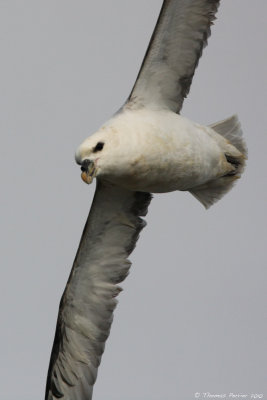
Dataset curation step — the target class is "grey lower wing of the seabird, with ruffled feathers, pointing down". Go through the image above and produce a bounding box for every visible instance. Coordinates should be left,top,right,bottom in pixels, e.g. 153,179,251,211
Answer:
45,181,151,400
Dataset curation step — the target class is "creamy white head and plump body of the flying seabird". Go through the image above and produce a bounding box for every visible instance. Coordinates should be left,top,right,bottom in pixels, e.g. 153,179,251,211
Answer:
76,107,244,203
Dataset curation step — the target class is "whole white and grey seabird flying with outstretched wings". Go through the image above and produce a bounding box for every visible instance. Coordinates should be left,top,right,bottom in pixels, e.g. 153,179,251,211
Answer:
45,0,246,400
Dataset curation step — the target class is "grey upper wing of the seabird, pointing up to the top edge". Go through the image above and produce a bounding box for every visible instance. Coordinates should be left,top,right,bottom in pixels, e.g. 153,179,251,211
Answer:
126,0,220,112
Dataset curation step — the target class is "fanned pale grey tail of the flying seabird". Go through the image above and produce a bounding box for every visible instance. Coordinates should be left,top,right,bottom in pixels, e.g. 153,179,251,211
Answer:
190,115,247,208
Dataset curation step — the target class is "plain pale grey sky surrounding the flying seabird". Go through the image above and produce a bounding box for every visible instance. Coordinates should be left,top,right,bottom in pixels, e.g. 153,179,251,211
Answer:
0,0,267,400
